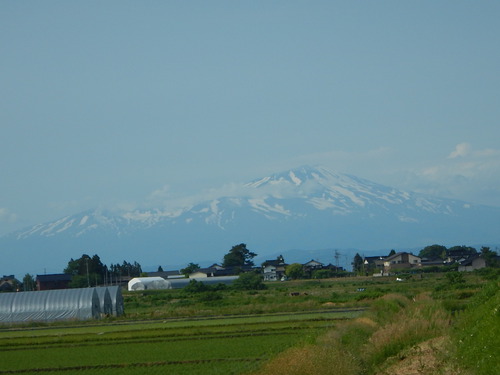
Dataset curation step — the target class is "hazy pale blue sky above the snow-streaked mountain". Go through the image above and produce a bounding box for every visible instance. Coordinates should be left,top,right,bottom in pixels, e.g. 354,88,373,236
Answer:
0,0,500,234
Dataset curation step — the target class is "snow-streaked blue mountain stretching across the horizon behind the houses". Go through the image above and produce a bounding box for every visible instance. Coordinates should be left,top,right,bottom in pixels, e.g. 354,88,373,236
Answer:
0,166,500,275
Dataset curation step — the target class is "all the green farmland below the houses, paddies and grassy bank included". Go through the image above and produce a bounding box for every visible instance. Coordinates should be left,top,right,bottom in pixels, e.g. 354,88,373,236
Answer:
0,274,499,375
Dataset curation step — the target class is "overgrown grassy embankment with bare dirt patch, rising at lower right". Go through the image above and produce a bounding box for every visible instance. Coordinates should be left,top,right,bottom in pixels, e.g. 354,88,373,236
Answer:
248,278,500,375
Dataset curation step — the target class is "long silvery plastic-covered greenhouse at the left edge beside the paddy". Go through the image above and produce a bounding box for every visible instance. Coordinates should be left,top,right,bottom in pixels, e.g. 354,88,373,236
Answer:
0,288,101,323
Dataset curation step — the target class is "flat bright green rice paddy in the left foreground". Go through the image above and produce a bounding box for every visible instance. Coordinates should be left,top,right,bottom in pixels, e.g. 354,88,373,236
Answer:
0,311,359,374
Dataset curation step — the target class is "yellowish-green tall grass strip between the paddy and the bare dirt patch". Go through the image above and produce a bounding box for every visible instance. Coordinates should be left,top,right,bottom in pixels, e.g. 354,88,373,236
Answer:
250,294,450,375
